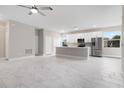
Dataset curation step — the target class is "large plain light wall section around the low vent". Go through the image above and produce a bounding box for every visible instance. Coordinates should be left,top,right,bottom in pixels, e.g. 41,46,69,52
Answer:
8,21,35,58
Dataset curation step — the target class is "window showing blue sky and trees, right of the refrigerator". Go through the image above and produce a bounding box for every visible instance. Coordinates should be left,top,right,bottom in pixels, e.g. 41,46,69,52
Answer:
103,31,121,48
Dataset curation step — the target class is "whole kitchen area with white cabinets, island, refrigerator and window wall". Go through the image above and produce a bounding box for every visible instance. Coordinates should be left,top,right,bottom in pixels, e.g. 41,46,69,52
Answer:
56,26,121,58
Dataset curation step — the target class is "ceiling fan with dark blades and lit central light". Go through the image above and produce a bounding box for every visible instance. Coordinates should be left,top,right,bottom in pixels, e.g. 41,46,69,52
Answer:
18,5,53,16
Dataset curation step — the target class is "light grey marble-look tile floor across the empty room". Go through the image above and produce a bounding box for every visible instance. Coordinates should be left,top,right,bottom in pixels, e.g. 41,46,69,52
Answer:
0,56,124,88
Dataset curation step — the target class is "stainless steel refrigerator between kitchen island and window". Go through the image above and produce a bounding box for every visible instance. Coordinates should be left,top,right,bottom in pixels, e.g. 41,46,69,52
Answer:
91,37,102,57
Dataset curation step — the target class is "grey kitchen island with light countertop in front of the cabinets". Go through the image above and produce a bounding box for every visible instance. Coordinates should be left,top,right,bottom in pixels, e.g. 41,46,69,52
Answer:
56,47,89,59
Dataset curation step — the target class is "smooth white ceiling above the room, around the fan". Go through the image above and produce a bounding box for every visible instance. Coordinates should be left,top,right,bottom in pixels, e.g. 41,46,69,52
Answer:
0,5,122,31
